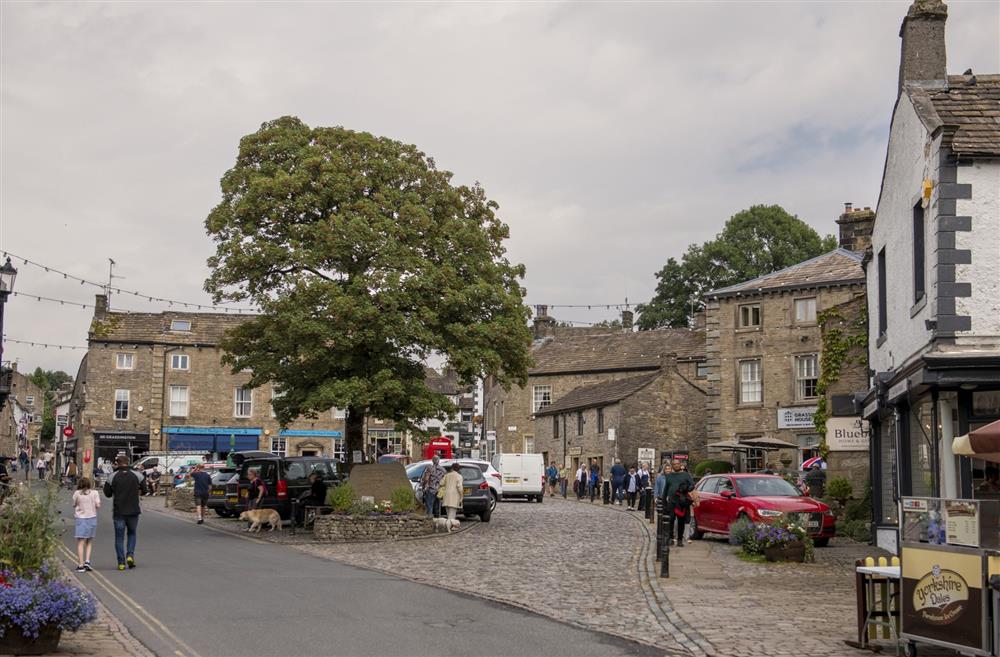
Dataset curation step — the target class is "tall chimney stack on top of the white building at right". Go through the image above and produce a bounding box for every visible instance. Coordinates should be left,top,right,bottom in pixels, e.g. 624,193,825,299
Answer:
897,0,948,96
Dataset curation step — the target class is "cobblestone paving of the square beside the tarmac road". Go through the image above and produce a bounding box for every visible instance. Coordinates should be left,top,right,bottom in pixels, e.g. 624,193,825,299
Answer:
150,497,956,657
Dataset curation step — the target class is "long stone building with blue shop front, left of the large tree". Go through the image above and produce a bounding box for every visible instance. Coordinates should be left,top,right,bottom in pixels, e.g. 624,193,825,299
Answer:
66,295,344,472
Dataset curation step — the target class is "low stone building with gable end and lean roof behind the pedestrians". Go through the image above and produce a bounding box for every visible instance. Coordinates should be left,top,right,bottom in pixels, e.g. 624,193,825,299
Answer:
534,354,706,471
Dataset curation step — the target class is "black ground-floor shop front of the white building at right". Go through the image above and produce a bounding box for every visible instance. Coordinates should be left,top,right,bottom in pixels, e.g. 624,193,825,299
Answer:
863,354,1000,554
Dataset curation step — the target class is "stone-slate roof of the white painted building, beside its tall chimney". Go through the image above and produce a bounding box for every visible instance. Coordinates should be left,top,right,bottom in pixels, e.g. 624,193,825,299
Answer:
906,74,1000,156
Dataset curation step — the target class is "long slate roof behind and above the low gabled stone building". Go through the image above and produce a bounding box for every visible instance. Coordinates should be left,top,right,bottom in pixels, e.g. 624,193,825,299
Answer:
528,329,705,375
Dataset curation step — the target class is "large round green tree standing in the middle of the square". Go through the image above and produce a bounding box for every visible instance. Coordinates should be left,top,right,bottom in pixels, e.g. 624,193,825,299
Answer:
205,117,531,466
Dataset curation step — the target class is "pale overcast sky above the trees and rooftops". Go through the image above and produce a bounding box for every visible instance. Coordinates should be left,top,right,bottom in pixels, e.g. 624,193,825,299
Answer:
0,0,1000,374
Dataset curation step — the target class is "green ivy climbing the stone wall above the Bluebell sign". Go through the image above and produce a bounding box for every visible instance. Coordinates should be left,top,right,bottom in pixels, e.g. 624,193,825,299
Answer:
813,303,868,459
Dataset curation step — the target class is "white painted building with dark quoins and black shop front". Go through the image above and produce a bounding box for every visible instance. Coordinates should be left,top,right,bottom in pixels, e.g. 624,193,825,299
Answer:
864,0,1000,551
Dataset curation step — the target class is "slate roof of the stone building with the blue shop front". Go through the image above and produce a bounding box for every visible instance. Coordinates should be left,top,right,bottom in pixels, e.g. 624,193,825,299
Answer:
88,312,253,346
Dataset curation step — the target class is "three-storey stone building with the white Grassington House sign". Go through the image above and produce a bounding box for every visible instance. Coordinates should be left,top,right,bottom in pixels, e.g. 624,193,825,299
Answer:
706,206,873,481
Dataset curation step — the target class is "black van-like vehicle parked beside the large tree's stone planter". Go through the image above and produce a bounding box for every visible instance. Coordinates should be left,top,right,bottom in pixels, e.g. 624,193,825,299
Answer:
226,454,346,520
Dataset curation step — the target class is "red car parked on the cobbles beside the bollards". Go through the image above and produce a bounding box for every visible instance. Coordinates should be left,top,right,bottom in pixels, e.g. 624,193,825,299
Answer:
691,474,837,547
